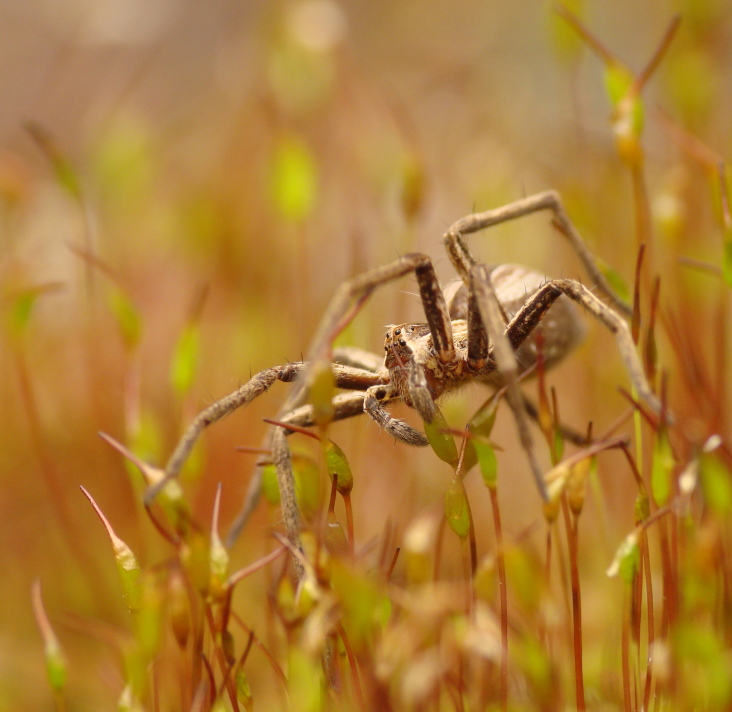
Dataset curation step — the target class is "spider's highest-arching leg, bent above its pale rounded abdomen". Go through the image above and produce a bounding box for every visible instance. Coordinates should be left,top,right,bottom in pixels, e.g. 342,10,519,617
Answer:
443,190,632,316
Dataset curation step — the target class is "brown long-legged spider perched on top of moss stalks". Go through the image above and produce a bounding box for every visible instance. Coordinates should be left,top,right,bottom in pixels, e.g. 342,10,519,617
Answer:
146,191,661,542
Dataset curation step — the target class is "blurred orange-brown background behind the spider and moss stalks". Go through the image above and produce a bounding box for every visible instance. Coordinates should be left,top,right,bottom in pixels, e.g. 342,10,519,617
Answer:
0,0,732,710
